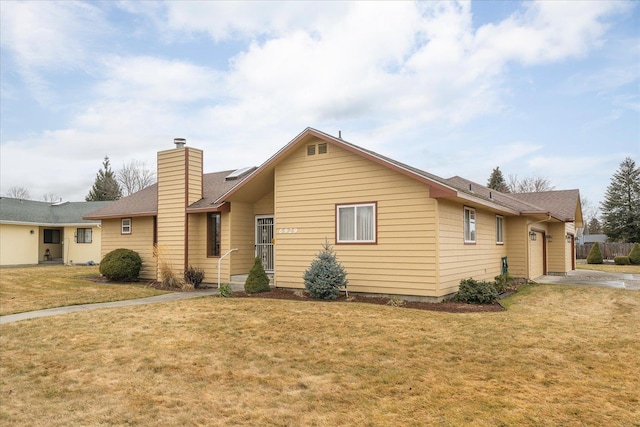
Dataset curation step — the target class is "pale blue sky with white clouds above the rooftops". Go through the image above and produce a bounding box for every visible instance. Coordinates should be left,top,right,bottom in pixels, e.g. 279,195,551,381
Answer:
0,0,640,212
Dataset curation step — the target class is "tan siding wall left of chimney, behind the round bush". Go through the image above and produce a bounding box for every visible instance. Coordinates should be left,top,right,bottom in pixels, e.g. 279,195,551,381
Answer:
100,216,157,280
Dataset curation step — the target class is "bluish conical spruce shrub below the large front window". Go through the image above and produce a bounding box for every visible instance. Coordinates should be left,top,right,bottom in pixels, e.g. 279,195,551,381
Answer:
302,241,349,299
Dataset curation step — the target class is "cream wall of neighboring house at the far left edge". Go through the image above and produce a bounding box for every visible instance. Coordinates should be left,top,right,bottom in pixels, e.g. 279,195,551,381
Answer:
0,224,38,266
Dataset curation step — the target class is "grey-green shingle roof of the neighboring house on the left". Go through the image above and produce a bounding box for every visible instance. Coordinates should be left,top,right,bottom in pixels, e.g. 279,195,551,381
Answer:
0,197,111,226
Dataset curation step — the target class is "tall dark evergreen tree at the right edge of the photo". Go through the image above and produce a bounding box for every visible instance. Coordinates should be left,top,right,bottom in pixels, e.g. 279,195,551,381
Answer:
601,157,640,242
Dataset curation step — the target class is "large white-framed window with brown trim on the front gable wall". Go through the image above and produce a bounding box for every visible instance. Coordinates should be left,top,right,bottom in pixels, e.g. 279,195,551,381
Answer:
336,203,376,243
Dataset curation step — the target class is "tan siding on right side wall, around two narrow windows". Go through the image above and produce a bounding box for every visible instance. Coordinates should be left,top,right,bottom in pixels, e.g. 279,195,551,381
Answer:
438,200,509,295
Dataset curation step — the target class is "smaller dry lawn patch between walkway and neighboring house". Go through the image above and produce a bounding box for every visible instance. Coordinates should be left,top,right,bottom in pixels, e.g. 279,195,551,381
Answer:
0,265,164,315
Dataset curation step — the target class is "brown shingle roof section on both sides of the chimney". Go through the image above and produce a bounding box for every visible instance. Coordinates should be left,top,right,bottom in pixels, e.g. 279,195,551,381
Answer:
85,170,238,219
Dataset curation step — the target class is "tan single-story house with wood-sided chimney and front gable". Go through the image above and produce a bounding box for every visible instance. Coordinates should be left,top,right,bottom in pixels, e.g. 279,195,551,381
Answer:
85,128,582,300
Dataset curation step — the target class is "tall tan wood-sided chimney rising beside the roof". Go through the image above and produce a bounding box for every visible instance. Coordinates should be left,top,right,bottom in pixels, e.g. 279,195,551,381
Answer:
158,147,202,277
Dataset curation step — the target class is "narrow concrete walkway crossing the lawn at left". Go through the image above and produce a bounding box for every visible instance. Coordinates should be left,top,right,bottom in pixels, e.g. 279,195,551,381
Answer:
0,289,219,325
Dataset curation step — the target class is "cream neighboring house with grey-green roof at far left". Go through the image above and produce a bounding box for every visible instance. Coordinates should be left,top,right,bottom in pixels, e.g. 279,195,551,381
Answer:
0,197,110,266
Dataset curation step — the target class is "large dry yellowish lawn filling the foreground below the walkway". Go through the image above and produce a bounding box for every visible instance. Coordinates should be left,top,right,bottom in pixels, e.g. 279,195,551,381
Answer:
0,285,640,426
